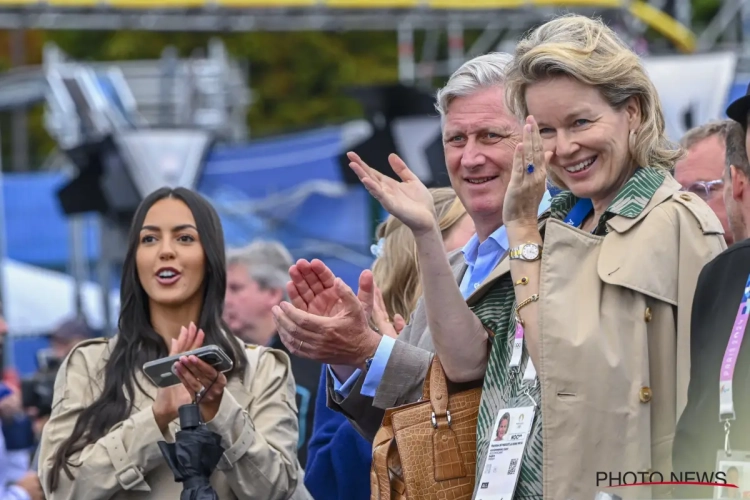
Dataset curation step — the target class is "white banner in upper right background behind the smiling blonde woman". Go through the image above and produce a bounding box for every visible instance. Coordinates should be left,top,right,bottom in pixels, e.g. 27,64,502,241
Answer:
643,52,737,142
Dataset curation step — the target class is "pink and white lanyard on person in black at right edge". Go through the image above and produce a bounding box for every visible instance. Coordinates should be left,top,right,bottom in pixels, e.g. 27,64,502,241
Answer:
719,276,750,453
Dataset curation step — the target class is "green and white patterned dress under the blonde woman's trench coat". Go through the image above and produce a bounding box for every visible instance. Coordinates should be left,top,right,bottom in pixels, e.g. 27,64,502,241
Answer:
472,168,664,500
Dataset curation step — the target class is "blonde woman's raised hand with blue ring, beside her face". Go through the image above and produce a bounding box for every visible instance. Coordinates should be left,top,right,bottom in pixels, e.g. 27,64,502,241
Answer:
503,116,552,227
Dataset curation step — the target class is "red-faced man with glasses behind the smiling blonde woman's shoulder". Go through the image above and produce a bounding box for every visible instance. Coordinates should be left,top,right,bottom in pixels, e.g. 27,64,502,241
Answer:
674,120,734,245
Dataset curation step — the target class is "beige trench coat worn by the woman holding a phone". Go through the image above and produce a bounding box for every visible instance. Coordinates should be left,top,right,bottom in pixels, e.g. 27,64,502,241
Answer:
39,339,309,500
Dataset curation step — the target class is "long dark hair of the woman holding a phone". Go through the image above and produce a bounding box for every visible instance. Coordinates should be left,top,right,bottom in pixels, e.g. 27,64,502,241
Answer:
49,188,247,491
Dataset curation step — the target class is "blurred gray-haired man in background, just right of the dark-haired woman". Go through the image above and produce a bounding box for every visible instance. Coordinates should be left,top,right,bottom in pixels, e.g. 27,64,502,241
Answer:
224,241,321,467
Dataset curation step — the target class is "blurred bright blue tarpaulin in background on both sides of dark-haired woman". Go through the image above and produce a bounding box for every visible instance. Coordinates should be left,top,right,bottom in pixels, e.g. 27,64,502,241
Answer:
3,128,372,286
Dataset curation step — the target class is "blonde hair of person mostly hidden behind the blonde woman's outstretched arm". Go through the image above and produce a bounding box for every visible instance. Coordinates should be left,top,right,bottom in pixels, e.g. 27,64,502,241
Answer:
372,188,466,321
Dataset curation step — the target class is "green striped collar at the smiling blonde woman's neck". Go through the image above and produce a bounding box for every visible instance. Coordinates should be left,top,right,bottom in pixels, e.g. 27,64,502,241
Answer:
550,168,664,220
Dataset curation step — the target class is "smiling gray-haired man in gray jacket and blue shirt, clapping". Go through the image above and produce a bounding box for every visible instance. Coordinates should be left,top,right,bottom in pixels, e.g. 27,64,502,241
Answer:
275,53,549,440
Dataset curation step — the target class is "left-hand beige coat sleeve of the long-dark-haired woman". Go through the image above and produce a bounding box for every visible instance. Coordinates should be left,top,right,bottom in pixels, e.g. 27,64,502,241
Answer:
39,345,164,500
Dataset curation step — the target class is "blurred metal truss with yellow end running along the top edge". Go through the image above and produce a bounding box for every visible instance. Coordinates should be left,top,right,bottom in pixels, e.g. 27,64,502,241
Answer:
0,0,704,52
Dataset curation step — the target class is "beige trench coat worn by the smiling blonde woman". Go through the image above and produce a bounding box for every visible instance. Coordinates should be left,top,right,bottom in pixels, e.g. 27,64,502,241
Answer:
470,176,726,500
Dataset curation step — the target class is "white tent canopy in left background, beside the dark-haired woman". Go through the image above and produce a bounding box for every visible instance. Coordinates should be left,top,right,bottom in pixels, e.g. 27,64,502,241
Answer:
2,259,120,336
